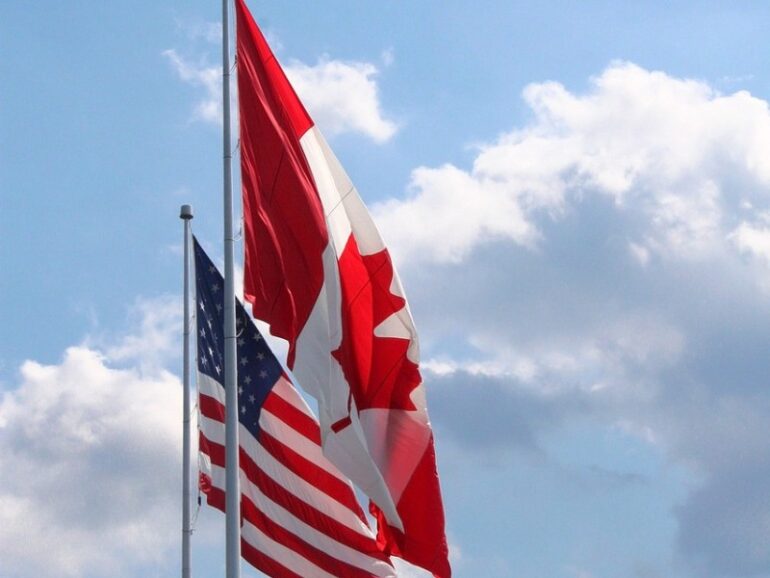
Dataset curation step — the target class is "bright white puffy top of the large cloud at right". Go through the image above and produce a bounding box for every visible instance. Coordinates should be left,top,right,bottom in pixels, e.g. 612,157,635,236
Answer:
374,63,770,262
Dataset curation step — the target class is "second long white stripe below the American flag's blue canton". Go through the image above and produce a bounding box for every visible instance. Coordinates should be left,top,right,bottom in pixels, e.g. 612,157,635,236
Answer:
211,465,395,577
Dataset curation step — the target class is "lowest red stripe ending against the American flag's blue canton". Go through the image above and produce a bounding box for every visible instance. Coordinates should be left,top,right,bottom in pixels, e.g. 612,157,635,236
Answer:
259,430,366,523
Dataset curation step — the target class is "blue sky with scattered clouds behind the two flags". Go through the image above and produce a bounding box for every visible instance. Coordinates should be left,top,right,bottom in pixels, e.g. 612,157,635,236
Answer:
0,0,770,578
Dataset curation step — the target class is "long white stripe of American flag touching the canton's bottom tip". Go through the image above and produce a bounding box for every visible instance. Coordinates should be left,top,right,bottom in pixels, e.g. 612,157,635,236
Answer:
201,417,374,539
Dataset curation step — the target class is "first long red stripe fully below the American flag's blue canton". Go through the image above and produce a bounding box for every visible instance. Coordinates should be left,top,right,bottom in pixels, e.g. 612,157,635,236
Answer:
201,434,387,561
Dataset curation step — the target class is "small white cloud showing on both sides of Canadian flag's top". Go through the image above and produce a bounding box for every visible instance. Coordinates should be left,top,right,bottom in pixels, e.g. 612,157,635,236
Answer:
163,50,398,143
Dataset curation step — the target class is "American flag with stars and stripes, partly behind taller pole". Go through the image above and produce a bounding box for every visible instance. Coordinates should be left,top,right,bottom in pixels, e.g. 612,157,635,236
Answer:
194,239,396,578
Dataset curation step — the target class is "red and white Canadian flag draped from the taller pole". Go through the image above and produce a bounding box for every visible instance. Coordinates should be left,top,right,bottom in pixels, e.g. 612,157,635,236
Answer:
236,0,451,578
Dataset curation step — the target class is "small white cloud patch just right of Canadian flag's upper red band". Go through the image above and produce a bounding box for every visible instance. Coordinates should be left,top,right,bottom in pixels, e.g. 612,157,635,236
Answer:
285,56,398,143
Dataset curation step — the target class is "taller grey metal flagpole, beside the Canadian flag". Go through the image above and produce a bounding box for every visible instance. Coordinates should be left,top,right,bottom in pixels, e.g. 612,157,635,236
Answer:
222,0,241,578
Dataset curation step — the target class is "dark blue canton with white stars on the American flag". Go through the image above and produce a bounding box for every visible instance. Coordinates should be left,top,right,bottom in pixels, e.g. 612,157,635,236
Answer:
193,237,283,438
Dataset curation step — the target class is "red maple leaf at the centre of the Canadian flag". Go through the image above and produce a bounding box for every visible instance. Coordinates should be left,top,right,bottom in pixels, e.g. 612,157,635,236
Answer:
332,235,422,418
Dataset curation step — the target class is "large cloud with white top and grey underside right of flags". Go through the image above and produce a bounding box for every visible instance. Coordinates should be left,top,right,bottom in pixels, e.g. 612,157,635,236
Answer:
382,63,770,578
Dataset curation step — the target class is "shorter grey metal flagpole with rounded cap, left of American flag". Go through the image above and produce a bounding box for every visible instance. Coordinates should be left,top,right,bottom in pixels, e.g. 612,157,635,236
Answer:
179,205,193,578
